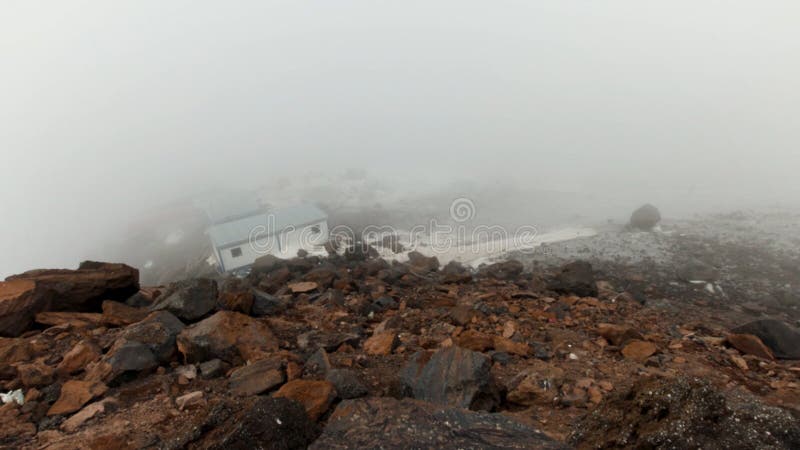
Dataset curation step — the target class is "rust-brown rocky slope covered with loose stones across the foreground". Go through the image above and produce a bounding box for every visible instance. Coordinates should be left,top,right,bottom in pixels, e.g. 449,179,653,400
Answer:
0,214,800,449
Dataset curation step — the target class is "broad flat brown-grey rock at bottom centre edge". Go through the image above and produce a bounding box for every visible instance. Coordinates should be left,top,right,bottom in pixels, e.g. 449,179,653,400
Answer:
309,397,566,450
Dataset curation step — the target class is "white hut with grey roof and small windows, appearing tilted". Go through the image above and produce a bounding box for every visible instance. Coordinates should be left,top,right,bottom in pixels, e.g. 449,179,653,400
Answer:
203,195,328,272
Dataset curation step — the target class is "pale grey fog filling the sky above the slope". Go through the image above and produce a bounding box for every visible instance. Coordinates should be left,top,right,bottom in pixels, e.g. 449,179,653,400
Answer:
0,0,800,277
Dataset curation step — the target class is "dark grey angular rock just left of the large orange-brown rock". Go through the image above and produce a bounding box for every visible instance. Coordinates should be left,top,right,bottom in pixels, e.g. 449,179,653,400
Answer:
119,311,185,363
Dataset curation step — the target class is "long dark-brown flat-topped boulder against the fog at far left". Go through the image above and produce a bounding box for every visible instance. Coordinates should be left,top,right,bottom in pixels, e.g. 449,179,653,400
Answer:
6,261,139,311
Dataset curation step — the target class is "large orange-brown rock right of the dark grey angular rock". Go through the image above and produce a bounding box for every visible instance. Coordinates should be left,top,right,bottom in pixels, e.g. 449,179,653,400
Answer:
177,311,278,365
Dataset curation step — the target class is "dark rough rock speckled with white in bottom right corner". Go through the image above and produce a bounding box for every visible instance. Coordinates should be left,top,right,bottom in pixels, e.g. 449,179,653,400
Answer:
571,378,800,450
